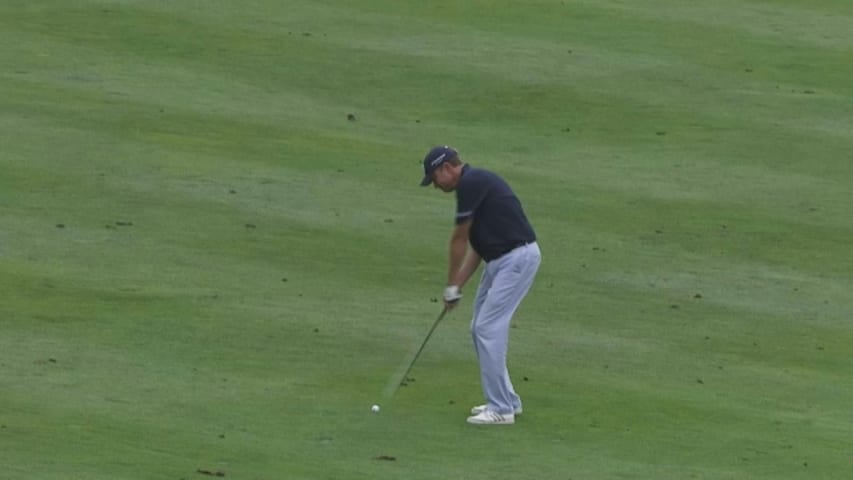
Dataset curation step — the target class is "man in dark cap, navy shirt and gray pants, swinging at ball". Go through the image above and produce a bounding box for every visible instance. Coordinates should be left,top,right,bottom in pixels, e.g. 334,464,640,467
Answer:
421,145,541,425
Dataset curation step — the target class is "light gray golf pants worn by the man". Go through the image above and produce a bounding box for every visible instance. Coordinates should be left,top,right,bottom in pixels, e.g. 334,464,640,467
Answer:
471,243,542,414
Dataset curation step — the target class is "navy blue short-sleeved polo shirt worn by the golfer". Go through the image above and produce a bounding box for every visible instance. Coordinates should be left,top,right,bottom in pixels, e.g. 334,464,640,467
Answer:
456,165,536,262
